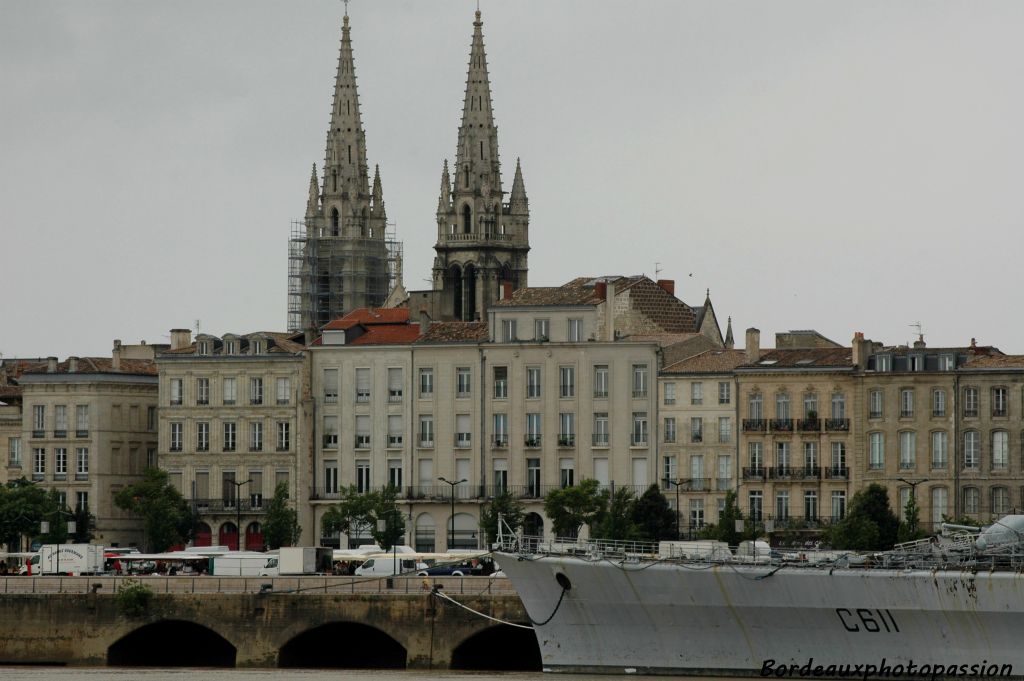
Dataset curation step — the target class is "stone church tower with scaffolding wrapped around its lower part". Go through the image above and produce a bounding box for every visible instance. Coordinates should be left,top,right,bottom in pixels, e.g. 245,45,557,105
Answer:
288,12,390,331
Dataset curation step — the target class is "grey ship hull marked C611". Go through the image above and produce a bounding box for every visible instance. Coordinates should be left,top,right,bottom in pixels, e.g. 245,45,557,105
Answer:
498,555,1024,679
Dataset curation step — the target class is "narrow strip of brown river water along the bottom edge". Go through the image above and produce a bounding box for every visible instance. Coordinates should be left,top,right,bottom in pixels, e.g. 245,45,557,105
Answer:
0,667,728,681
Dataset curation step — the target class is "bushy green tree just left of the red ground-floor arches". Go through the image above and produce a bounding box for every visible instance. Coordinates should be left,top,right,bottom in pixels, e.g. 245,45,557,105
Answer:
114,468,196,553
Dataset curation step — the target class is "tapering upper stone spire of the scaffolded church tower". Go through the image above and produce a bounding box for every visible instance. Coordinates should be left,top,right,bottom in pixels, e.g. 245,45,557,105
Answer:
324,12,370,199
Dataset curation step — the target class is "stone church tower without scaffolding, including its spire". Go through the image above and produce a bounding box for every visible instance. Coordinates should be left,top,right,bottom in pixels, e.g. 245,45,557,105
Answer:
433,10,529,321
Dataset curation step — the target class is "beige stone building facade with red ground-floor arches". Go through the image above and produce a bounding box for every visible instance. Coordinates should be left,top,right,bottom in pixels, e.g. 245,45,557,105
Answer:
157,329,312,550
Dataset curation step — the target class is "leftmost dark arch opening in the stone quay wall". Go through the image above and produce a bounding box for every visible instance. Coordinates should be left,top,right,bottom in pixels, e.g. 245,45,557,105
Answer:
106,620,237,667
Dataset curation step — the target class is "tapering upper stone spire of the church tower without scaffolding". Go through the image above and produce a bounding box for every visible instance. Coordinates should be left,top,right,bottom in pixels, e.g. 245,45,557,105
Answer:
455,10,502,200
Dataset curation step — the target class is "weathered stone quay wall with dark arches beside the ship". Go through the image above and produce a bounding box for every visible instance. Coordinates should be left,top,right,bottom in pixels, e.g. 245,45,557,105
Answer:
0,578,541,671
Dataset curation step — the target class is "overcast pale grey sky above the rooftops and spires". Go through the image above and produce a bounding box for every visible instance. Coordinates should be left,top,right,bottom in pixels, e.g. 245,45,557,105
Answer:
0,0,1024,357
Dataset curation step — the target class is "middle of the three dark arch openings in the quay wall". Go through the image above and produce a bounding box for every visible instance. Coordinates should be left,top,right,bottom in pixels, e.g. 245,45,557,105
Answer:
278,622,408,669
